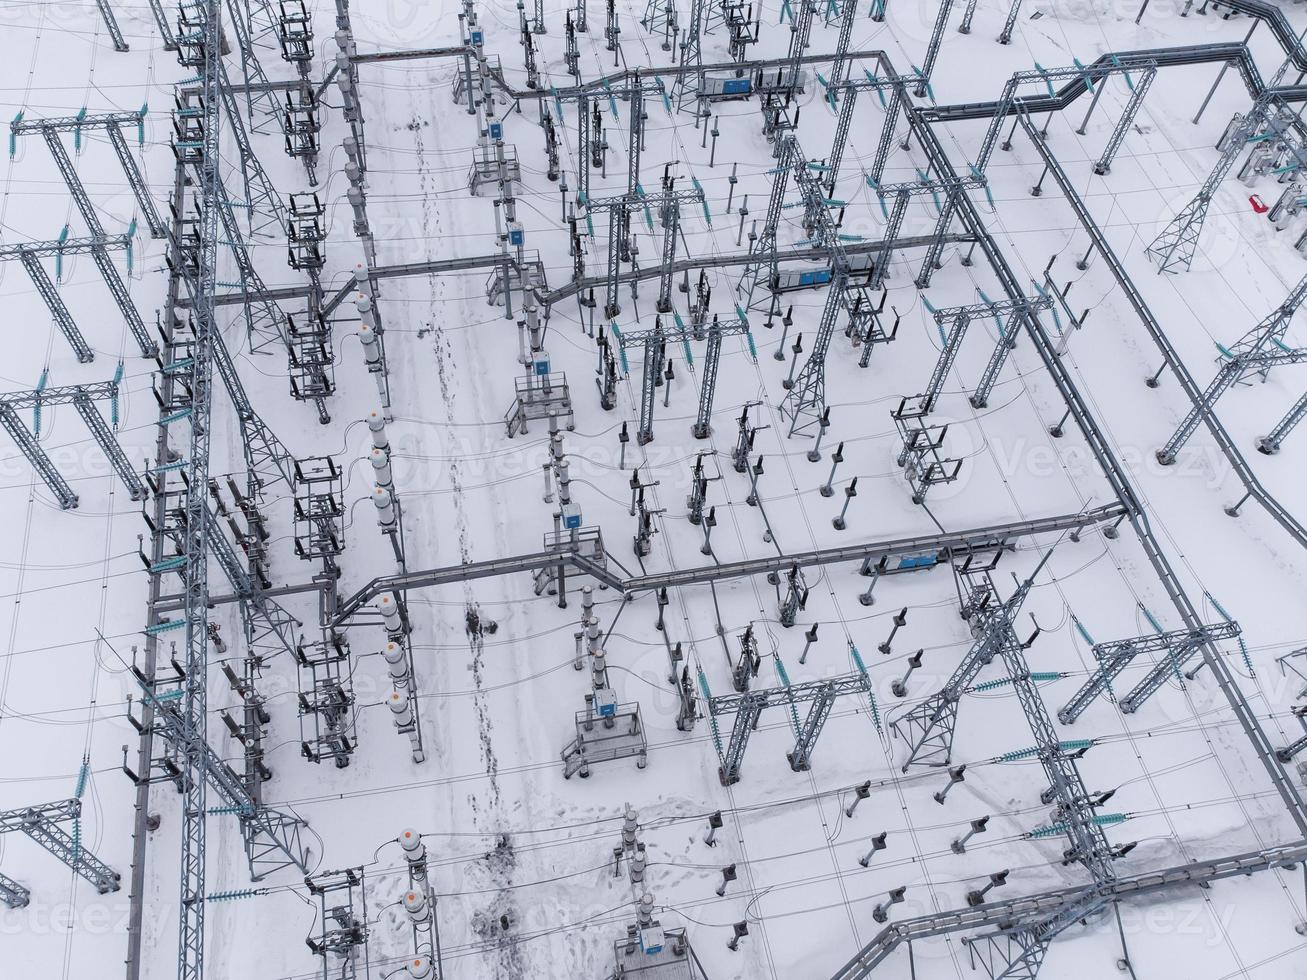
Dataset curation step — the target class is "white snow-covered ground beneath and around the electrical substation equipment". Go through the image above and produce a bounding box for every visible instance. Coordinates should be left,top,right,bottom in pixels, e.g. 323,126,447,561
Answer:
0,0,1307,980
